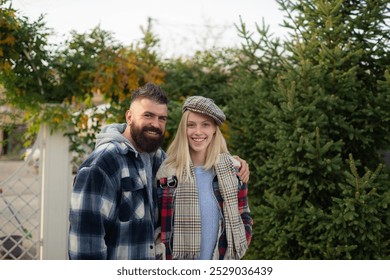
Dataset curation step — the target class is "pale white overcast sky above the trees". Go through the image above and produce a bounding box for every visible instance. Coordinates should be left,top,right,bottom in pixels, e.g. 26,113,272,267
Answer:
12,0,286,56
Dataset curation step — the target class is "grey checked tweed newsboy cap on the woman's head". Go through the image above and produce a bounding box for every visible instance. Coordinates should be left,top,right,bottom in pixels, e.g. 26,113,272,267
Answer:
182,96,226,126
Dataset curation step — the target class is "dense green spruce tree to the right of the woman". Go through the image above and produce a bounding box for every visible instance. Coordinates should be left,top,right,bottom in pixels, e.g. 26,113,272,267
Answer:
232,0,390,259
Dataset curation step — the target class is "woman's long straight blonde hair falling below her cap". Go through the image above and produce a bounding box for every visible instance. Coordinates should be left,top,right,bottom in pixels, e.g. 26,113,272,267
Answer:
165,111,228,181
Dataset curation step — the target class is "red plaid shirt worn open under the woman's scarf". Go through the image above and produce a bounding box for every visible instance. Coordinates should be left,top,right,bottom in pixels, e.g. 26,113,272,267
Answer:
157,176,253,260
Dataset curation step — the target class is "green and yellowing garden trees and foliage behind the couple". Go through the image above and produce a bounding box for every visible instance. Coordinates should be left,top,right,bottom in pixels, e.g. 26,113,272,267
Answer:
0,0,390,259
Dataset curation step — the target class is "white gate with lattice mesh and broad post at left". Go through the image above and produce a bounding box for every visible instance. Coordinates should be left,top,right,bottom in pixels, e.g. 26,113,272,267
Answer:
0,125,73,260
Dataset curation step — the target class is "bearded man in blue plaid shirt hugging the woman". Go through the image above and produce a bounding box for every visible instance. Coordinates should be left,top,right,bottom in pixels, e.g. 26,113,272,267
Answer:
68,83,249,260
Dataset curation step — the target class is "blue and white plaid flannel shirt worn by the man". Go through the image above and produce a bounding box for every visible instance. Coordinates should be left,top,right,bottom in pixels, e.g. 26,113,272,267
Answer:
69,123,165,260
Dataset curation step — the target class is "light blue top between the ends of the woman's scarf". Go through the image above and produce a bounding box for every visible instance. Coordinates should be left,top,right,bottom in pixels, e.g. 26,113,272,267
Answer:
195,167,220,260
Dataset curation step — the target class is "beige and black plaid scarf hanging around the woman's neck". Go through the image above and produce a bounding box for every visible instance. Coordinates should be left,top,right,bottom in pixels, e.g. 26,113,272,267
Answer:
172,154,248,259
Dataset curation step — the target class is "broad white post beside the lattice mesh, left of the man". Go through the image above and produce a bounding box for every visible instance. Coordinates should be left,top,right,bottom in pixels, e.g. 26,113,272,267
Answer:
40,125,72,260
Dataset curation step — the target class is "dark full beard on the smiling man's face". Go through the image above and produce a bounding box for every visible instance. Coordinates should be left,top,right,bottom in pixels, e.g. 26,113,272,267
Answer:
130,122,164,153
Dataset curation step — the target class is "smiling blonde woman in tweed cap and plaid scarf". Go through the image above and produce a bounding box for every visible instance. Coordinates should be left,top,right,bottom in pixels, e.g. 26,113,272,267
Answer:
157,96,253,260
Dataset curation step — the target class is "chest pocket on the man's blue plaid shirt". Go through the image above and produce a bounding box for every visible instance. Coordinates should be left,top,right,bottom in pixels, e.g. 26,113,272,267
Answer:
119,177,147,222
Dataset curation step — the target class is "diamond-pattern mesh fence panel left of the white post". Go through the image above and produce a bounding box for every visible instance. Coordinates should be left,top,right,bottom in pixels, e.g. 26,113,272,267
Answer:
0,135,41,260
